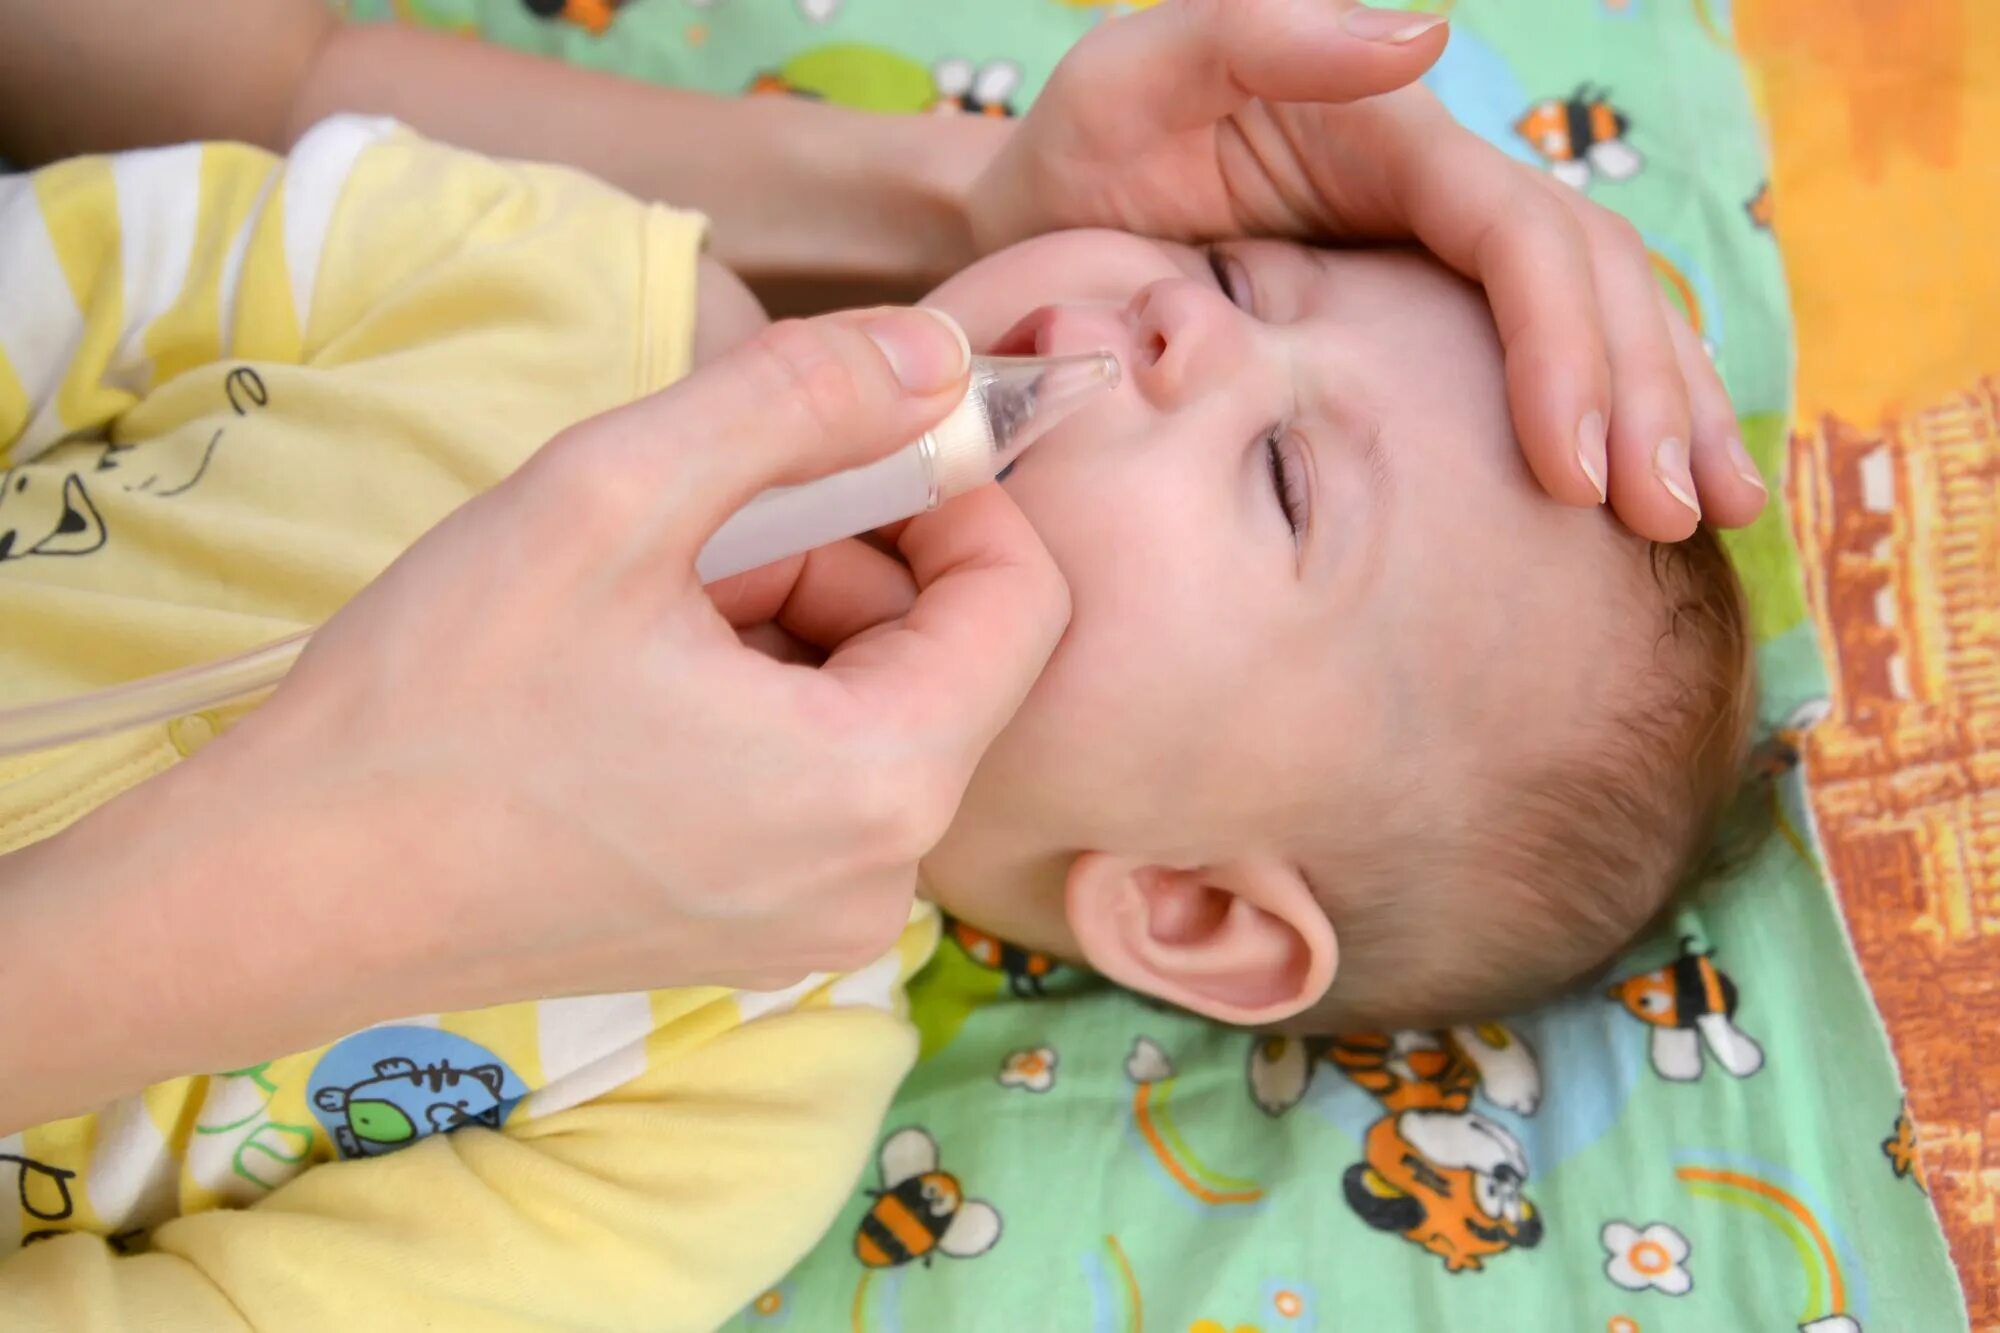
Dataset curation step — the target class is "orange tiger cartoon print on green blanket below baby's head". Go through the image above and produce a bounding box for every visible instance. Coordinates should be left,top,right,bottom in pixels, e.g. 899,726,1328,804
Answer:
1250,1023,1542,1273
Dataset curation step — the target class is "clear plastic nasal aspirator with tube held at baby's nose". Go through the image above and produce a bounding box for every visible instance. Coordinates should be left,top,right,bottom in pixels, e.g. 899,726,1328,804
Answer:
0,352,1118,755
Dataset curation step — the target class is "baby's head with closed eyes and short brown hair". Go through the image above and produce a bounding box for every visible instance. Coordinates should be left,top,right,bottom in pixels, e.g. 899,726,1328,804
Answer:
924,232,1750,1029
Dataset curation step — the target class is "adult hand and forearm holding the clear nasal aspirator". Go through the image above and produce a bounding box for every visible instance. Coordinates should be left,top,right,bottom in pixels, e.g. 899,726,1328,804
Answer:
0,300,1068,1133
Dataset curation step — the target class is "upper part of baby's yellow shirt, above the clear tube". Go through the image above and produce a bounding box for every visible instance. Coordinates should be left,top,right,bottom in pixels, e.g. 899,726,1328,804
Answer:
0,118,704,707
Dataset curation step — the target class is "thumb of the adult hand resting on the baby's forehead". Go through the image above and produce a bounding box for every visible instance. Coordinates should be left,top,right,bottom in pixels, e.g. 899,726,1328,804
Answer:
1056,0,1446,132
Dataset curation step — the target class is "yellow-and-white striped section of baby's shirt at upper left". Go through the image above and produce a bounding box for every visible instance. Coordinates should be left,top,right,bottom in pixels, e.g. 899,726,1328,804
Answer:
0,118,364,464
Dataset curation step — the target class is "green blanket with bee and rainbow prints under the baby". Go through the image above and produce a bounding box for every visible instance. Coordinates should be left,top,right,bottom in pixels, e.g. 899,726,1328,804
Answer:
354,0,1966,1333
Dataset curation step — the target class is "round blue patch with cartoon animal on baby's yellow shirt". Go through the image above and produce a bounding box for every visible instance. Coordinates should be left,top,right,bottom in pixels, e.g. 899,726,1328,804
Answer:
306,1027,526,1157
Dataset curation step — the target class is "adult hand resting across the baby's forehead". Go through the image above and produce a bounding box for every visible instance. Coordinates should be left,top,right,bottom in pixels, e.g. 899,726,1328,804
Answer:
970,0,1764,540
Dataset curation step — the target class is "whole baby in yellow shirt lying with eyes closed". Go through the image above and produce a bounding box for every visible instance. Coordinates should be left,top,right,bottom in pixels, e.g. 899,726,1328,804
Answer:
0,120,1748,1329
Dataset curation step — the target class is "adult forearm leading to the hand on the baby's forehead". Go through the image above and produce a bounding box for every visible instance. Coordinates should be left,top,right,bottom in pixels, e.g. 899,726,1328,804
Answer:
290,24,1006,290
